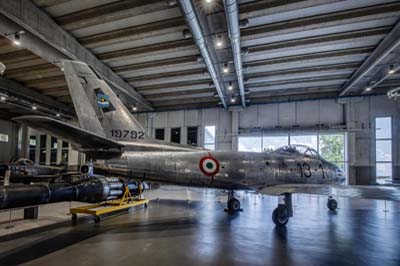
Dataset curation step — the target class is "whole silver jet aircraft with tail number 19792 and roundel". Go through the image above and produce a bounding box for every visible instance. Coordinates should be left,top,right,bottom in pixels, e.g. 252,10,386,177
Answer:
12,60,400,226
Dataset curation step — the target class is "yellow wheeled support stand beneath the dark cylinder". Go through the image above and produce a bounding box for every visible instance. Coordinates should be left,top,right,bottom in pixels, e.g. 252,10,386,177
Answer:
69,184,149,223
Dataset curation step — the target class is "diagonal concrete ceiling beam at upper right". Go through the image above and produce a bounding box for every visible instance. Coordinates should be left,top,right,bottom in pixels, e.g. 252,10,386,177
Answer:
339,17,400,96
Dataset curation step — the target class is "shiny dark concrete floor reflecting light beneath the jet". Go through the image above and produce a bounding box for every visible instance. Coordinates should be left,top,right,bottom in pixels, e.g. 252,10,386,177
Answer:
0,187,400,266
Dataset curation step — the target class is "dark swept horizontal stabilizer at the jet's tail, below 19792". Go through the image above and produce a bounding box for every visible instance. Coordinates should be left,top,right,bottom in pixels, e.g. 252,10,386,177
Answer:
14,115,124,159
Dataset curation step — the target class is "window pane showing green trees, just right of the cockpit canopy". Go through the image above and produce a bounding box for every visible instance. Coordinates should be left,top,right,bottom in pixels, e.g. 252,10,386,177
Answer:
319,134,344,163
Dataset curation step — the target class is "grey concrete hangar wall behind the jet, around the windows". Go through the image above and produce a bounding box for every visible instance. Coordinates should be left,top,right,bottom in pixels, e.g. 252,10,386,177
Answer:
137,95,400,184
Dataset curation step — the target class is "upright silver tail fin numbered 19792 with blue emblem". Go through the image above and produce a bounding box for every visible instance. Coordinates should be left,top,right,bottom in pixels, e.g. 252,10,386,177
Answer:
62,60,149,142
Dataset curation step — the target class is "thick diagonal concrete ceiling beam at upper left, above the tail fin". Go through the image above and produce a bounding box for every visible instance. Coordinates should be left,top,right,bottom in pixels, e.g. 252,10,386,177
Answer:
0,0,153,110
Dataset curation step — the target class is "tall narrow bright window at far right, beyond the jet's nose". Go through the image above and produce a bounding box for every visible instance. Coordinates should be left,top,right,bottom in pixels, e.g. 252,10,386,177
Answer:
375,117,392,183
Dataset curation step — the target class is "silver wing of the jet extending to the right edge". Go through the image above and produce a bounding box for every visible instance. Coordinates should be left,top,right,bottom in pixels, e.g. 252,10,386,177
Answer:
256,184,400,201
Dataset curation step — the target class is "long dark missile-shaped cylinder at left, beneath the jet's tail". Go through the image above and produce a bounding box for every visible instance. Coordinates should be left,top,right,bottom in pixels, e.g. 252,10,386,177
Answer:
0,176,144,209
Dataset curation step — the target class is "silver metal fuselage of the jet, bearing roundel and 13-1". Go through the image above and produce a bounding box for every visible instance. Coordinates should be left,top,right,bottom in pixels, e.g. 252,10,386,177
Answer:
107,151,344,190
